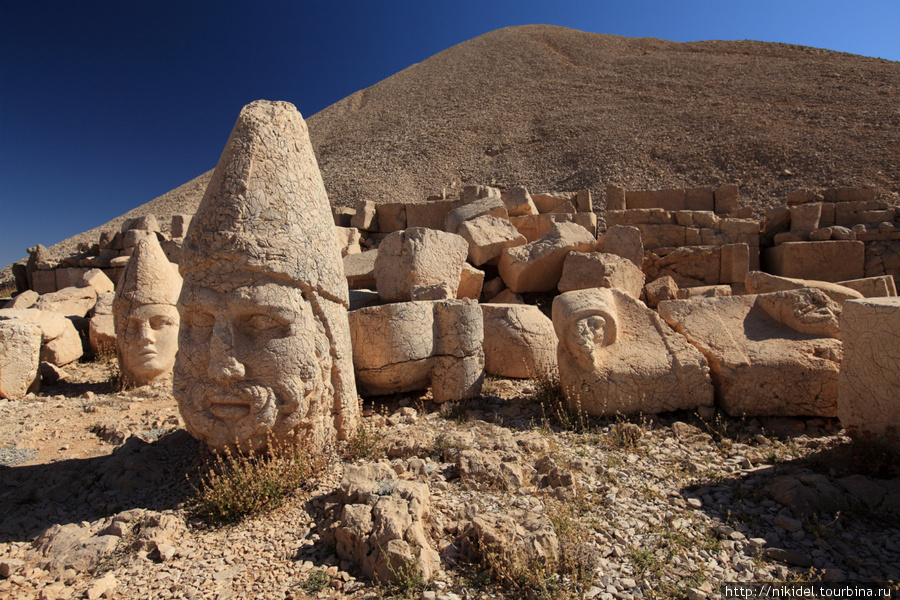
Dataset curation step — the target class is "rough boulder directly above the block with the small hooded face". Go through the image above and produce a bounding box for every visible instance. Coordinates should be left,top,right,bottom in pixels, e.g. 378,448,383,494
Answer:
557,252,644,298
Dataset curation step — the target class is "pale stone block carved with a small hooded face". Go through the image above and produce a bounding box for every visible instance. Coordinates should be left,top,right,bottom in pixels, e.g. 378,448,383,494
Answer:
553,288,713,415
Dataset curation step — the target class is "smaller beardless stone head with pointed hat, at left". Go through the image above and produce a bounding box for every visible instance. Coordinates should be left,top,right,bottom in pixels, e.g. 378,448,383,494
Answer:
113,236,181,385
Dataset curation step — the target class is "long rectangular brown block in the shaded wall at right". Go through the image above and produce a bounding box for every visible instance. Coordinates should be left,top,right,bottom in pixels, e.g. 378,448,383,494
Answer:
763,240,866,282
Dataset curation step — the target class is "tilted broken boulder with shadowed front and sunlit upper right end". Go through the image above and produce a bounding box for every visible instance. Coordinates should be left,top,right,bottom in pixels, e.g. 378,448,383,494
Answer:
499,223,596,293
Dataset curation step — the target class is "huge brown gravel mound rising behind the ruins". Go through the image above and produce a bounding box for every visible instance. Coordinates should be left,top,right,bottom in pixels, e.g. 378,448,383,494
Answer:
26,25,900,264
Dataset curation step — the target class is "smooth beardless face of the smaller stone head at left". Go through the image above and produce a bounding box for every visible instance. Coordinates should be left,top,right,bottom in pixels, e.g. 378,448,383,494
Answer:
118,304,179,385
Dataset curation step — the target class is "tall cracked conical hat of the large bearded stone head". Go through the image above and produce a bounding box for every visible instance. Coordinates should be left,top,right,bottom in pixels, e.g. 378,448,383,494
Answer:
181,100,348,306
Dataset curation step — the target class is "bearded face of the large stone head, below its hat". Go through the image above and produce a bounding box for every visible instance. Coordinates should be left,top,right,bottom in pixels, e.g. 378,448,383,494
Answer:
175,282,331,451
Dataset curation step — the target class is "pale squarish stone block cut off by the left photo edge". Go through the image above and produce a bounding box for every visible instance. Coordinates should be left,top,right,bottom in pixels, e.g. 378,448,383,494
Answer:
0,320,41,400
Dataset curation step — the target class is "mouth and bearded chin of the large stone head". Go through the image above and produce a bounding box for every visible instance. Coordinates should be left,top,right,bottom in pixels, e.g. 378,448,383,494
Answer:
175,381,309,452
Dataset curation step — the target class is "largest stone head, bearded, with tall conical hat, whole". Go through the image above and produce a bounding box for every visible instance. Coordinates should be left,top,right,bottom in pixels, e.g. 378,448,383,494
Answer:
175,101,358,450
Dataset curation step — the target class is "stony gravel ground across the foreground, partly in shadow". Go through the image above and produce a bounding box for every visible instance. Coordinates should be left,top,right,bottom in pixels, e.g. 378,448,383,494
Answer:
0,361,900,600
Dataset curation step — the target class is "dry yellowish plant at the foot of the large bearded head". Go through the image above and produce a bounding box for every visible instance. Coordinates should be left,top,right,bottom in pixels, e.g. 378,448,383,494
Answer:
188,442,327,524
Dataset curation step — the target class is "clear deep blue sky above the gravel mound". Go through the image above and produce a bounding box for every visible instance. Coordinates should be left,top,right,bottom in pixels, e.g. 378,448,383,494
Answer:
0,0,900,267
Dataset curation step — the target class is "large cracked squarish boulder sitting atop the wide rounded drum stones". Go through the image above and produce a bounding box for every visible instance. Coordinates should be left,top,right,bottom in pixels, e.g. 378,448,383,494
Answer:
375,227,469,302
